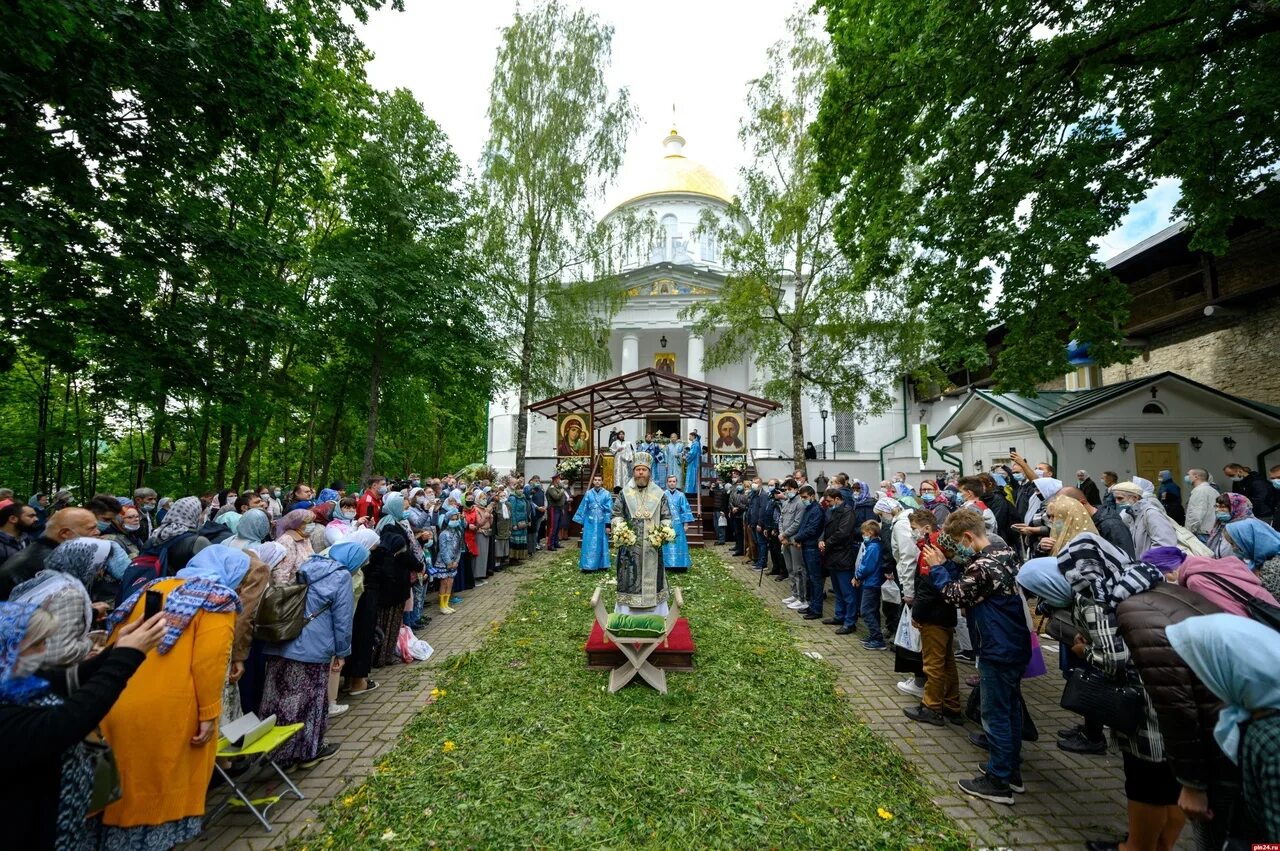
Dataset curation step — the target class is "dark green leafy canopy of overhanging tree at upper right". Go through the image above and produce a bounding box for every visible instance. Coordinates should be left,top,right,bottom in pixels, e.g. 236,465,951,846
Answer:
814,0,1280,392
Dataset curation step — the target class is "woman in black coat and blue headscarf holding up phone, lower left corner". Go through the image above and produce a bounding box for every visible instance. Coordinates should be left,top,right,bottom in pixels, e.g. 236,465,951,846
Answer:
0,601,165,851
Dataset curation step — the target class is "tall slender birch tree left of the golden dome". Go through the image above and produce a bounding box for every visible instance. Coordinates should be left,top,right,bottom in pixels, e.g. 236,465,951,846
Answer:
480,3,634,468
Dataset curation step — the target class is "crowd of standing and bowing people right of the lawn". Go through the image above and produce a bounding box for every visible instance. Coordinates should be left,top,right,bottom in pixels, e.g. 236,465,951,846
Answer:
713,453,1280,851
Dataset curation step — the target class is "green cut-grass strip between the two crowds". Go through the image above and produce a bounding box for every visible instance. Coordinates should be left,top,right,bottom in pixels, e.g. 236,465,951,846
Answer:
297,550,968,850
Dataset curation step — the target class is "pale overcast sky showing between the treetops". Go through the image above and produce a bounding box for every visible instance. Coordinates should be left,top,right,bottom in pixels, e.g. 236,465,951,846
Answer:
361,0,1178,258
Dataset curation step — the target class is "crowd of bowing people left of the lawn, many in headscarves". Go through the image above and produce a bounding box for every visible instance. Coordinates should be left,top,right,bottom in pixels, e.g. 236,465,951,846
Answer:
0,475,560,851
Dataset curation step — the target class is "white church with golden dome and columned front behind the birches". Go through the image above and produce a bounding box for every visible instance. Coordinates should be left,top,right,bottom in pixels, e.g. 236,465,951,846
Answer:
488,128,942,477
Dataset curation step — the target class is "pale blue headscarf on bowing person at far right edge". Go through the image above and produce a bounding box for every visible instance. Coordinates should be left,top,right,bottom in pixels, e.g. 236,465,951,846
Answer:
1165,614,1280,763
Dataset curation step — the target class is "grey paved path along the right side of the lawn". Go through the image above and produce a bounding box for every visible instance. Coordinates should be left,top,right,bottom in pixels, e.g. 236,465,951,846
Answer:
712,548,1194,851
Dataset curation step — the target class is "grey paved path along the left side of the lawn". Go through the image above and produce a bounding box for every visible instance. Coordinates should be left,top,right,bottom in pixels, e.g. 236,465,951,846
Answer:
183,553,552,851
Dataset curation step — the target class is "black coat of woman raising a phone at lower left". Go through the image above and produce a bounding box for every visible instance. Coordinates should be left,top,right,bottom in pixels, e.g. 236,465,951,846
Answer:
0,648,146,848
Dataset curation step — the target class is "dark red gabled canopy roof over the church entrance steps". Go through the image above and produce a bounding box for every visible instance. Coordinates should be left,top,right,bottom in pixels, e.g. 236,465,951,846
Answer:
529,367,782,429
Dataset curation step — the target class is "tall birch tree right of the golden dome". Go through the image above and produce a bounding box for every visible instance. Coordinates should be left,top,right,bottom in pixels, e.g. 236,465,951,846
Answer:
689,13,919,465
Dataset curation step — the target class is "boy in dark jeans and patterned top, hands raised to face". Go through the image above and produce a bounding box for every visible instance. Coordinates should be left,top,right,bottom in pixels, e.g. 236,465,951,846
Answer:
924,511,1032,804
